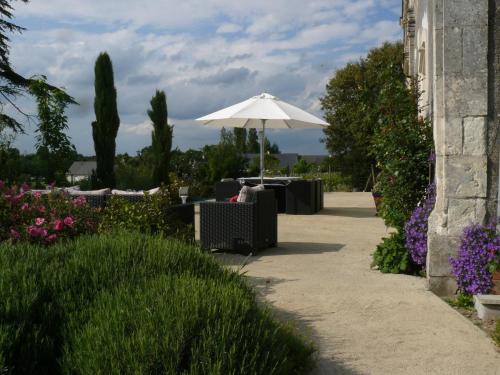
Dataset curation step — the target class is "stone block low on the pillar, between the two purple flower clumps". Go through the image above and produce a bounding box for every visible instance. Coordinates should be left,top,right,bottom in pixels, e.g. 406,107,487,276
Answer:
427,234,460,277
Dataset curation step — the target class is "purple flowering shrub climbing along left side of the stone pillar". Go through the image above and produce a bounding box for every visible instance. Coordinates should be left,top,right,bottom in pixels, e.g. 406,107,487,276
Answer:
405,184,436,267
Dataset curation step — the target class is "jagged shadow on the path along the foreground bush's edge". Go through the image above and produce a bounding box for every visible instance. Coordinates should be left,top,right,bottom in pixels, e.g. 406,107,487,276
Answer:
248,275,365,375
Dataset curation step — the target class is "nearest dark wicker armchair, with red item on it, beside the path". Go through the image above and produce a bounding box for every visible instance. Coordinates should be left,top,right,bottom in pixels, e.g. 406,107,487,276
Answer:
200,190,278,254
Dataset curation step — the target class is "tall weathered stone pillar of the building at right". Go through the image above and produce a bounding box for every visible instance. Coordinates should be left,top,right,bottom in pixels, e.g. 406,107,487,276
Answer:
427,0,498,294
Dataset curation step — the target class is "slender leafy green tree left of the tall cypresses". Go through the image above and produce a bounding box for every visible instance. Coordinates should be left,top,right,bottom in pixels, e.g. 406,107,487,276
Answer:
30,77,76,182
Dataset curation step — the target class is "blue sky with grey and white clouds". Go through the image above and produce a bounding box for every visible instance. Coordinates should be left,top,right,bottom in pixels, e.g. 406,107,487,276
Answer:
11,0,402,155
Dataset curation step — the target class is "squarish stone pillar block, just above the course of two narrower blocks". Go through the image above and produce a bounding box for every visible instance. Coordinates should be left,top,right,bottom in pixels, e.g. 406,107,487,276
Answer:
444,69,488,118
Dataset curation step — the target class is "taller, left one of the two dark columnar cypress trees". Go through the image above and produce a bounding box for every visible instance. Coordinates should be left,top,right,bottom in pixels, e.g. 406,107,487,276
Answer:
92,52,120,188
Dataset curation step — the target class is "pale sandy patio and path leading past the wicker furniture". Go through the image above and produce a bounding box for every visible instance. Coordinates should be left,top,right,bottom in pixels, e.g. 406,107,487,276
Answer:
197,193,500,374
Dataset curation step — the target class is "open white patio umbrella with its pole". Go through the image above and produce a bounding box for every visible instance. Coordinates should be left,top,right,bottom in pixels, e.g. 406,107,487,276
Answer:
196,93,328,183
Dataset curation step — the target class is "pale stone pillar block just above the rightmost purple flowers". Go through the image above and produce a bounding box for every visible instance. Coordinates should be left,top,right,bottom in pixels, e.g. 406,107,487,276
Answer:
448,199,486,235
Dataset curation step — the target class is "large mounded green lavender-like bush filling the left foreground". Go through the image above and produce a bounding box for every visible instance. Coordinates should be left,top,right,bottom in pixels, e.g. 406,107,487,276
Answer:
0,232,313,375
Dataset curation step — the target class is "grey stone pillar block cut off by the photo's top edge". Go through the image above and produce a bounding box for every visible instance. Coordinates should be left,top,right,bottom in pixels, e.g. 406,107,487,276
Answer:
443,0,489,27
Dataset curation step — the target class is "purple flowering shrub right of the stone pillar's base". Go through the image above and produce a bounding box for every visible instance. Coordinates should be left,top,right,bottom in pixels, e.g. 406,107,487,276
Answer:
450,224,500,294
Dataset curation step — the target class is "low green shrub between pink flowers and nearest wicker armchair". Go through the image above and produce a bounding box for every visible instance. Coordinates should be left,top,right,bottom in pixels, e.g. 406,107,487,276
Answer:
99,184,194,240
